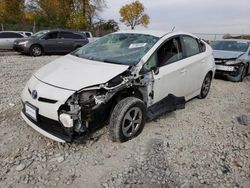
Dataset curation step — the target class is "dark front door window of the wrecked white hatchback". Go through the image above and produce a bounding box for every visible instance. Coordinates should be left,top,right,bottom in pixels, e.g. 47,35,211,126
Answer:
157,37,183,67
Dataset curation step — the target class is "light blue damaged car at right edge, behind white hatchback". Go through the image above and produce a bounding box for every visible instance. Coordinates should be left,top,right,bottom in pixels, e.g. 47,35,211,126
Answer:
212,39,250,82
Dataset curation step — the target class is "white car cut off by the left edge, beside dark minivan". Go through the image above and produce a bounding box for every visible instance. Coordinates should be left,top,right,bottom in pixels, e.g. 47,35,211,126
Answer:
0,31,27,50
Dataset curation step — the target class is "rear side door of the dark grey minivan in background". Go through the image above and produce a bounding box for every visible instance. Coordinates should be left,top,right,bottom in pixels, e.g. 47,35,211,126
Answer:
58,31,75,53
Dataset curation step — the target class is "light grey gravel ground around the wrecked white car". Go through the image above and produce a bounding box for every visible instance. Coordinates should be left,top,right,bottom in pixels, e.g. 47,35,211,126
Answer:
0,52,250,188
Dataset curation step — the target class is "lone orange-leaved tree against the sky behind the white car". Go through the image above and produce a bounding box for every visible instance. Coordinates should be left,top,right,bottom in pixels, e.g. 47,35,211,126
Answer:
120,0,149,29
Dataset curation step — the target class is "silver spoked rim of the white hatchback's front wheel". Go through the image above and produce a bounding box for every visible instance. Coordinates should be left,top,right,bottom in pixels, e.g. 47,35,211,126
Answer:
122,107,142,137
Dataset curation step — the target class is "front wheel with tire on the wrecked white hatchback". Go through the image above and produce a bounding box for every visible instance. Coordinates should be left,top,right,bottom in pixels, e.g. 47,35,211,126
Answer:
109,97,146,142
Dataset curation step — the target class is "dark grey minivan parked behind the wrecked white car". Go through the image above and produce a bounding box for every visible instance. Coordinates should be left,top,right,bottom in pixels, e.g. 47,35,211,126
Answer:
13,30,89,56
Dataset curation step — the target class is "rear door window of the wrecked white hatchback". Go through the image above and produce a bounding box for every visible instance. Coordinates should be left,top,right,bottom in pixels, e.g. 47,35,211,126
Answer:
182,36,200,57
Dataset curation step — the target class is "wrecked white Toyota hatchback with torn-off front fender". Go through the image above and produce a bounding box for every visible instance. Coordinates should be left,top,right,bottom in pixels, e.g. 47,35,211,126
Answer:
21,31,215,142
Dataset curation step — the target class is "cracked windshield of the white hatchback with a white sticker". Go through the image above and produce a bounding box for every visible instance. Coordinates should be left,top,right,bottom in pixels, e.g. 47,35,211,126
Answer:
72,33,159,65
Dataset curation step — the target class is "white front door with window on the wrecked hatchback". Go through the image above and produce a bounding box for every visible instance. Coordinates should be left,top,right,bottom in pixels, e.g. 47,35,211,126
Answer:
151,36,187,103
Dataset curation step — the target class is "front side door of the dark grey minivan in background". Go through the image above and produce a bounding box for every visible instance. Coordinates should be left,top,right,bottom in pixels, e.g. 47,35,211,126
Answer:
40,31,62,53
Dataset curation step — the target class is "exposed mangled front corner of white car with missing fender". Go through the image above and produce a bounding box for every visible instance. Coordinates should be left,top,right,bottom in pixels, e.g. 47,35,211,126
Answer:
58,67,153,139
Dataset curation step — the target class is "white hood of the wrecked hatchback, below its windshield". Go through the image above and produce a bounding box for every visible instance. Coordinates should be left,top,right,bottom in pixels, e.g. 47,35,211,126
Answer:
34,55,129,91
